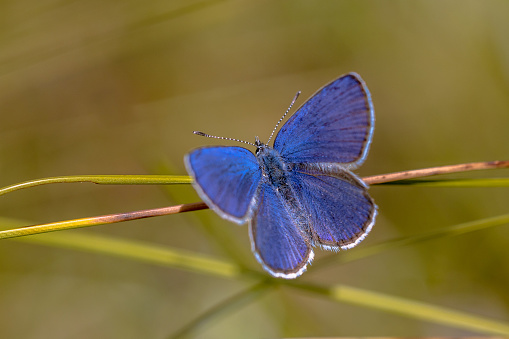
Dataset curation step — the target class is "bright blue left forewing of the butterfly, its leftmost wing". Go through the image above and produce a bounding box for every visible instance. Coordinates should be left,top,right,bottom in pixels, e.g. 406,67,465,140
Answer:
184,146,262,224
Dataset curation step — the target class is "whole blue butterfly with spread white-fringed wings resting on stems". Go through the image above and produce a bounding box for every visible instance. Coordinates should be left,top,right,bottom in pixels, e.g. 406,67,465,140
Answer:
185,73,377,279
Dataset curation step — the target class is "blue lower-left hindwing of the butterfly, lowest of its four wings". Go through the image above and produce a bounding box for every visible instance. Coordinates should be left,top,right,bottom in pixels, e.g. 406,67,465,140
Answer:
249,183,313,279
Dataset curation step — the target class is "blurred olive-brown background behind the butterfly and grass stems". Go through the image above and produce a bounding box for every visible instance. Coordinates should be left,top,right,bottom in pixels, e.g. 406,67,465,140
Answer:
0,0,509,338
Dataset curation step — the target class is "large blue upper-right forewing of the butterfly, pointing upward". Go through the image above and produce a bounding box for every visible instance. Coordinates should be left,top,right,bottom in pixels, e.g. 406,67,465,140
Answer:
274,73,375,169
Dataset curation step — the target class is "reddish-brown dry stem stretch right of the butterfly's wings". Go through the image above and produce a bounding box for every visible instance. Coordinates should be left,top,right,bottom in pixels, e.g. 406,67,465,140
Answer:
362,160,509,185
